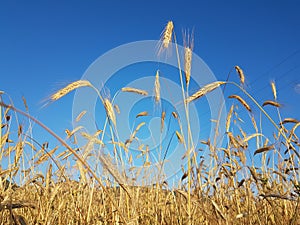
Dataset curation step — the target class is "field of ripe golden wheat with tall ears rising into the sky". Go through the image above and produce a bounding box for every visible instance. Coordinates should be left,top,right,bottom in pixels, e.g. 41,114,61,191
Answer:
0,21,300,225
